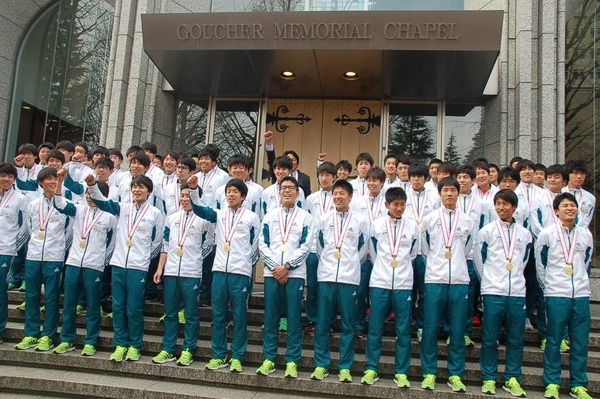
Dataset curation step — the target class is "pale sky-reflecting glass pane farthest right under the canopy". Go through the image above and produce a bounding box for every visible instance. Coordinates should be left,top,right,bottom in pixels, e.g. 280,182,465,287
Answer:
444,105,485,165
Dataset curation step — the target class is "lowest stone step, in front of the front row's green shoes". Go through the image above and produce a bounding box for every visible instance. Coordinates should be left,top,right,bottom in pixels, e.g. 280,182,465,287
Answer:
0,345,580,399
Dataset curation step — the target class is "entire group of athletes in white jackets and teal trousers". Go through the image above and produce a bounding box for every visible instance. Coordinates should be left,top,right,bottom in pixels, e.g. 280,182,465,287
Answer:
0,132,595,399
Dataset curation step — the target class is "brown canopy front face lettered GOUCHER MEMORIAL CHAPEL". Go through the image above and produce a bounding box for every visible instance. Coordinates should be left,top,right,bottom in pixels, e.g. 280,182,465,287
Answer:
142,11,502,51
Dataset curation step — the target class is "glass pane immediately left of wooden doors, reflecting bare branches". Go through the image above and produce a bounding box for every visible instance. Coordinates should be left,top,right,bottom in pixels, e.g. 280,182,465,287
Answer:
213,101,259,169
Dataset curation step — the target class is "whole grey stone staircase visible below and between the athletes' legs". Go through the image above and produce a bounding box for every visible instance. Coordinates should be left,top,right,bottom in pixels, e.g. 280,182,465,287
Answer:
0,292,600,399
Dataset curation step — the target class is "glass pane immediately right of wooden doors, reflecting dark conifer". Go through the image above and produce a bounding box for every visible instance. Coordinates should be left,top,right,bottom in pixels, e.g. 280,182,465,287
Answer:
388,104,437,164
